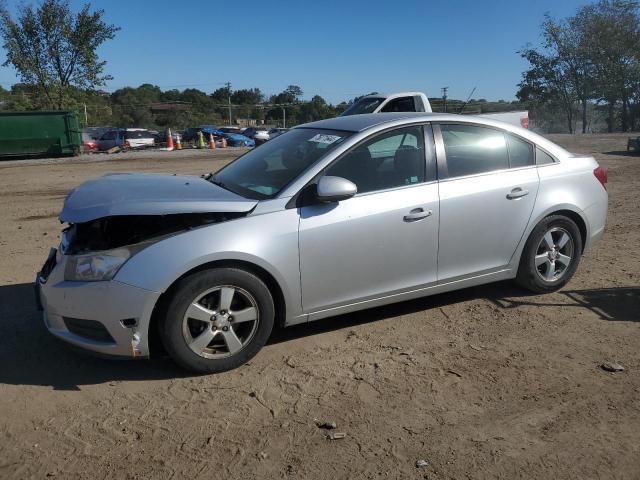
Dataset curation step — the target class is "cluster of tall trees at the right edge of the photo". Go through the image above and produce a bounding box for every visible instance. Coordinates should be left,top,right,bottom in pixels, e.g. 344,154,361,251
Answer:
517,0,640,133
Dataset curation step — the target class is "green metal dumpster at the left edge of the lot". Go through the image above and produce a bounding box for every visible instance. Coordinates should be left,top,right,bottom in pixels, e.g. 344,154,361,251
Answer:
0,112,82,158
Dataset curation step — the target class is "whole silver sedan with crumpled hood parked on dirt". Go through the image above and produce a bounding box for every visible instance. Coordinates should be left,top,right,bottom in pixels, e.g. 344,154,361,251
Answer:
36,113,607,372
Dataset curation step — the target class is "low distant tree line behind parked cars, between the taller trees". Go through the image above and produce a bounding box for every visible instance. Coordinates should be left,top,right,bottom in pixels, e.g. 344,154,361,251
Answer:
0,84,523,129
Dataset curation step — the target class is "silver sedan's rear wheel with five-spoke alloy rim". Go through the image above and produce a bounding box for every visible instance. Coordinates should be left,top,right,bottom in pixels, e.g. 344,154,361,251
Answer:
516,215,582,293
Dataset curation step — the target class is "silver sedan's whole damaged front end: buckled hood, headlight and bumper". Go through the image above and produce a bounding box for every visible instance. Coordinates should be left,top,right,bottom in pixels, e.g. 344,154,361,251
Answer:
35,174,257,358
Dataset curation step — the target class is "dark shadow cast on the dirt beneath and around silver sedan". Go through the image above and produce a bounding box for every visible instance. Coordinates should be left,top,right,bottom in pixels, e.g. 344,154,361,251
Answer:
0,282,640,390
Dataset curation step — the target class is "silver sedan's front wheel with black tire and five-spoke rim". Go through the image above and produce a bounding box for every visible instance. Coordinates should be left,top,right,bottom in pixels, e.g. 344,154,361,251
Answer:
160,268,275,373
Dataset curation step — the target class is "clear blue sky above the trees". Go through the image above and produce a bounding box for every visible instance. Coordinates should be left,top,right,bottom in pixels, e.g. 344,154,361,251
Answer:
0,0,590,103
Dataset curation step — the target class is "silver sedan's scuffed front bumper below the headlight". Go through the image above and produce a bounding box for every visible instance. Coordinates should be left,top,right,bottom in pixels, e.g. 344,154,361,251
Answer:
36,256,160,358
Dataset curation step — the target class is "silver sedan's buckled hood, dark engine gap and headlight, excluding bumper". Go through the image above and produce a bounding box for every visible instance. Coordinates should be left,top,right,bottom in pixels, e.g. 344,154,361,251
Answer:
55,174,256,282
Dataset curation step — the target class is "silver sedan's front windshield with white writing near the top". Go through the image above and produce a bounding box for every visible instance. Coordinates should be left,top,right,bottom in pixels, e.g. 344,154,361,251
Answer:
210,128,351,200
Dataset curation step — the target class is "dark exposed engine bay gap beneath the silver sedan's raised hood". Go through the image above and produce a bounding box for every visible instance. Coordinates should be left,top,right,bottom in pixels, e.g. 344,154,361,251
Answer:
62,212,246,255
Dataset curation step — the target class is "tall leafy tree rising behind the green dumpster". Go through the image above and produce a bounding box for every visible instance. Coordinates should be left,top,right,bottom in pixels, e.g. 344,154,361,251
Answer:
0,0,119,108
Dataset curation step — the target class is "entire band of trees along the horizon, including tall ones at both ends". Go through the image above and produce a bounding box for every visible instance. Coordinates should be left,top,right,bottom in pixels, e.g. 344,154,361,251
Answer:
0,0,640,132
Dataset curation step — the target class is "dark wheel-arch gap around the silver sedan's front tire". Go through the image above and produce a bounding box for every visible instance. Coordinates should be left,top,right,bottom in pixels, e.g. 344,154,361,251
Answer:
148,260,287,355
